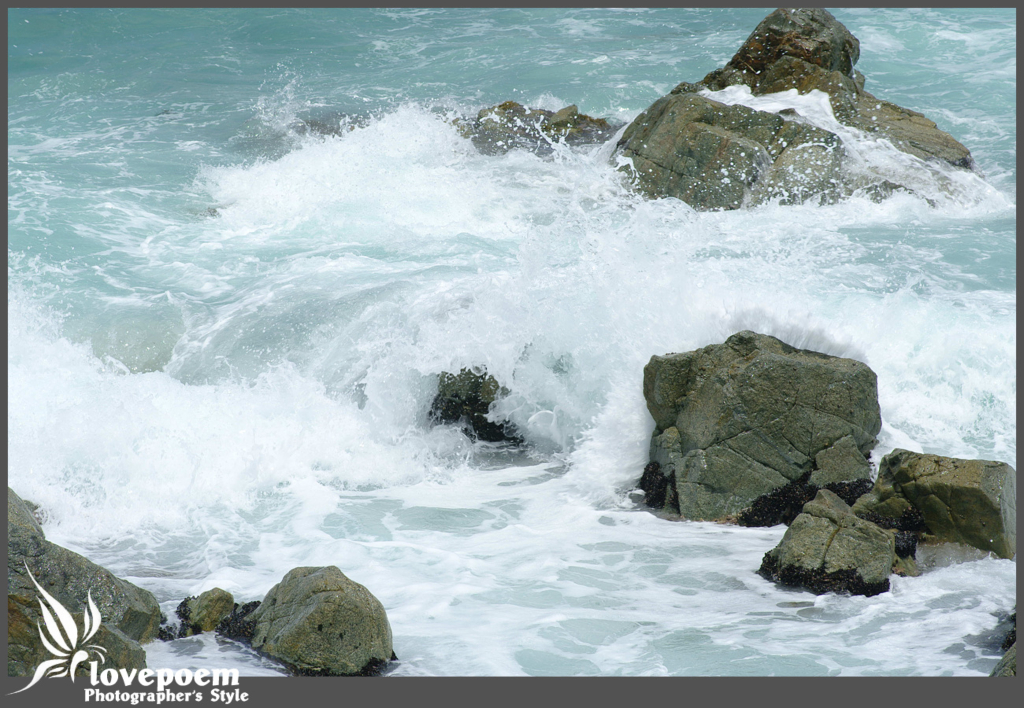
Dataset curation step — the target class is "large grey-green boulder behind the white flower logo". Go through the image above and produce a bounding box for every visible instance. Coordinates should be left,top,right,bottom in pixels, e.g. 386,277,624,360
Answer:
7,487,161,676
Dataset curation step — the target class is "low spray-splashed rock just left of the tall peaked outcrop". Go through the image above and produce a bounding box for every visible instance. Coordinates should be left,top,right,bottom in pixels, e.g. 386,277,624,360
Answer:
457,100,622,155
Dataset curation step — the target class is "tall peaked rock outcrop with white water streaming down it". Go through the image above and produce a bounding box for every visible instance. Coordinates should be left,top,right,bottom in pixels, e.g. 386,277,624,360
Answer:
612,8,974,210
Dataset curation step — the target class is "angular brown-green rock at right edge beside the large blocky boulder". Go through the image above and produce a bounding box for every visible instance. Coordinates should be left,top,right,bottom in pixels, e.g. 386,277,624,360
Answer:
853,449,1017,558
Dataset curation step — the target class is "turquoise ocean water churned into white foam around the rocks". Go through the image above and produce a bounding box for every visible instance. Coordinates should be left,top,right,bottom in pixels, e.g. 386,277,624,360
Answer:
7,9,1017,676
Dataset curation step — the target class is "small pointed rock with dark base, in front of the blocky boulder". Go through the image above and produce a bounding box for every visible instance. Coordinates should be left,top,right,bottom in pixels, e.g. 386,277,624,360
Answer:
758,490,896,596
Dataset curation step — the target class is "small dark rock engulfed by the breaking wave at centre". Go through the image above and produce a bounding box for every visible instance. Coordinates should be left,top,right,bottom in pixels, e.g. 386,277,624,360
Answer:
430,369,522,444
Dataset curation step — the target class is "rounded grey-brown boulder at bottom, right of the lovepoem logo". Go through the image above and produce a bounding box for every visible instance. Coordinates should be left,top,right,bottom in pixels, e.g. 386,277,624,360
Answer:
252,566,394,676
